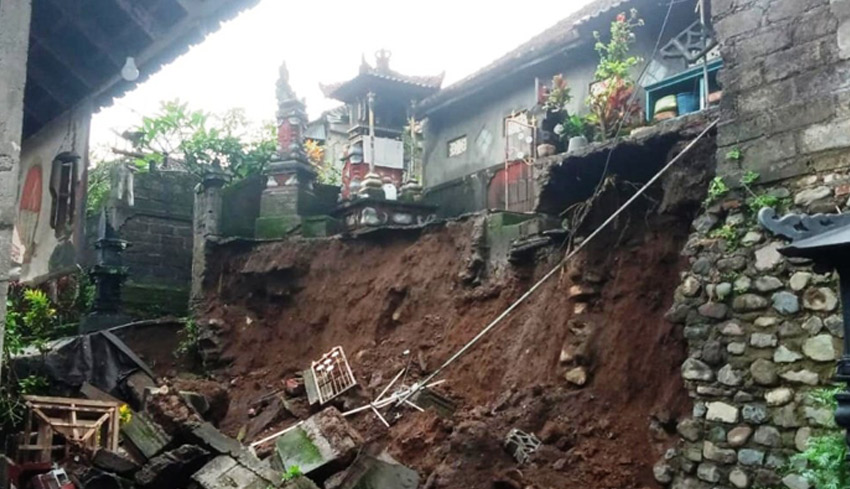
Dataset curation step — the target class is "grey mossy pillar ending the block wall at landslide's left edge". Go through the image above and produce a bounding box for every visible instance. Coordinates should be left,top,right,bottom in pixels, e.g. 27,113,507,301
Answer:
189,171,227,311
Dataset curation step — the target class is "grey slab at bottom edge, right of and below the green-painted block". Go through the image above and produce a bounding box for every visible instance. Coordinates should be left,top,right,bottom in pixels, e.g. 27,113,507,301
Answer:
325,453,419,489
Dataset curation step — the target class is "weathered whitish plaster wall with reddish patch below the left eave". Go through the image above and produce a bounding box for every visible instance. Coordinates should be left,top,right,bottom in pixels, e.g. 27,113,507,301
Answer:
13,104,92,282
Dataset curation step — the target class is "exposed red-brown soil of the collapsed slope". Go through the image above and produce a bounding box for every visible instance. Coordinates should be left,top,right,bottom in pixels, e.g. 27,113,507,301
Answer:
203,188,689,489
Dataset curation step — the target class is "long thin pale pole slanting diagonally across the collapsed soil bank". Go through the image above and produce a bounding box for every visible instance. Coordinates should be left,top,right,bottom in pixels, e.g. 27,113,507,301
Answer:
396,120,718,406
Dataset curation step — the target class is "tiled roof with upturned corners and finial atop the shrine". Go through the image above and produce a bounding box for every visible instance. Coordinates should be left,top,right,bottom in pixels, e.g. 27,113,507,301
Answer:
319,50,445,102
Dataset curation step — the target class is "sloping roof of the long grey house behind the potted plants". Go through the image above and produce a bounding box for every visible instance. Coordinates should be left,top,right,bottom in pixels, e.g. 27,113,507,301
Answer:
419,0,640,114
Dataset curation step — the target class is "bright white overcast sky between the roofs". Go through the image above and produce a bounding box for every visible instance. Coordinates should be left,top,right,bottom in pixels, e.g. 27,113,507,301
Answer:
91,0,590,154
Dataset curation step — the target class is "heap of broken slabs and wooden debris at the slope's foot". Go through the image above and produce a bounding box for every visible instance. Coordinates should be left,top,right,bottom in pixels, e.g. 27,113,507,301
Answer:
3,346,419,489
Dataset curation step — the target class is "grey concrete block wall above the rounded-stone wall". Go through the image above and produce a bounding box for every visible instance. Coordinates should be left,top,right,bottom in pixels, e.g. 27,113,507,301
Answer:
711,0,850,181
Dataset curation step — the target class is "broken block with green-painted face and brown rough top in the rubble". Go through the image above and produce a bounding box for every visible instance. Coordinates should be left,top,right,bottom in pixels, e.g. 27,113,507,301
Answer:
275,407,363,474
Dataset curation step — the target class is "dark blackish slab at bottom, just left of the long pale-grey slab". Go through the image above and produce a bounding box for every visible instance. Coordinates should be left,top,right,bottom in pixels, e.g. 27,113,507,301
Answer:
135,445,210,488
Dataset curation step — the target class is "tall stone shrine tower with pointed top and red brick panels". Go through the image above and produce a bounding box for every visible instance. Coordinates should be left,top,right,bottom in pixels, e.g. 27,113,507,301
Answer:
255,64,316,239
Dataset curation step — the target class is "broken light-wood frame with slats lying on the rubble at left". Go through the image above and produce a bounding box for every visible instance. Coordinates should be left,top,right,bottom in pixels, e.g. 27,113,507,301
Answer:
18,396,121,463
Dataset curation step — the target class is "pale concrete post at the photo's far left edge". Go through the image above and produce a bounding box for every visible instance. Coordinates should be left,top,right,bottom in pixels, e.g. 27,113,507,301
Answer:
0,0,32,374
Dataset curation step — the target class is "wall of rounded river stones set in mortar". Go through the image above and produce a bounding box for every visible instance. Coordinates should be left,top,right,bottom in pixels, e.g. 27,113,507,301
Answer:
655,171,850,489
